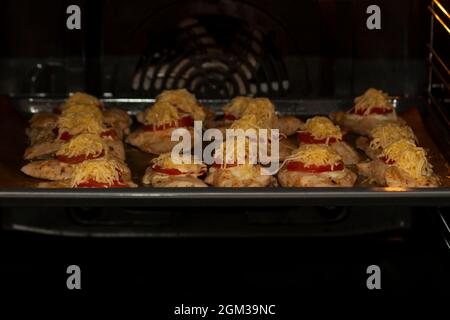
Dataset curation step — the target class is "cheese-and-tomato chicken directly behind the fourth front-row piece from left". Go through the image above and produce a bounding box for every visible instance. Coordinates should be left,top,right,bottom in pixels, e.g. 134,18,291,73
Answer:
298,116,359,165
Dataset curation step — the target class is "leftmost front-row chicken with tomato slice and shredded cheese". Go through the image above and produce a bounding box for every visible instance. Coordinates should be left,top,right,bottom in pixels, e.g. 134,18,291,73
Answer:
38,159,137,188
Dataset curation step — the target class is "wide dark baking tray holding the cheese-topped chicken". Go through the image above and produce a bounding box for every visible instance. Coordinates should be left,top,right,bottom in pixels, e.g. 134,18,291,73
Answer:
0,96,450,207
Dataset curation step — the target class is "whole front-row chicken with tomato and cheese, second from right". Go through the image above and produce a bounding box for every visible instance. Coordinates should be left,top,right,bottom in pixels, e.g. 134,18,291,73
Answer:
278,144,357,187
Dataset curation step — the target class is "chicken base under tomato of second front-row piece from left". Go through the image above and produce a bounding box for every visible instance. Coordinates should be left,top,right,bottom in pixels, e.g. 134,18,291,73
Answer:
142,166,207,188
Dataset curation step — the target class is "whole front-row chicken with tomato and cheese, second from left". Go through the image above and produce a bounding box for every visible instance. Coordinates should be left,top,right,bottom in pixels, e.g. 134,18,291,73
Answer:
142,153,207,187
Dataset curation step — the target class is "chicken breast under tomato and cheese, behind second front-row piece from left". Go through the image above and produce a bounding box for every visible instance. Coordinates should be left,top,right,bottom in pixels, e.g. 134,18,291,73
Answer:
126,128,194,154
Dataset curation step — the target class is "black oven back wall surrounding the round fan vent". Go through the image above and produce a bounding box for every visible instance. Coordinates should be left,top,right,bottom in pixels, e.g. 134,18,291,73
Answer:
0,0,429,97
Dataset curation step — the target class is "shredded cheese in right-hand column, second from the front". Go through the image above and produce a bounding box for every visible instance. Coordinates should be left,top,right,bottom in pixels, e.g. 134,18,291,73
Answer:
370,123,417,150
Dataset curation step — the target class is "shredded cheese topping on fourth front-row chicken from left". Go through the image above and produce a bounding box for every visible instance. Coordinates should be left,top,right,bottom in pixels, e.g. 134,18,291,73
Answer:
283,144,342,168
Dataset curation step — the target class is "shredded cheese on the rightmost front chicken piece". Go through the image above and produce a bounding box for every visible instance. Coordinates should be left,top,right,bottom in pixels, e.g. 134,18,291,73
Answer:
381,139,433,179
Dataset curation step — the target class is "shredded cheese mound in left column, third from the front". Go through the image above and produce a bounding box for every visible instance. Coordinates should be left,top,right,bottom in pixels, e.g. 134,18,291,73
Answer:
58,112,104,135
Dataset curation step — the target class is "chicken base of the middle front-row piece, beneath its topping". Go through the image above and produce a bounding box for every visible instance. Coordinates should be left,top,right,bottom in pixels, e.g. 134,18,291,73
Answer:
205,165,274,188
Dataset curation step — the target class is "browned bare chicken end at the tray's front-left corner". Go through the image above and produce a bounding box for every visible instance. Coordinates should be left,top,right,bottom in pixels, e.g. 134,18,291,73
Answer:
21,159,74,180
